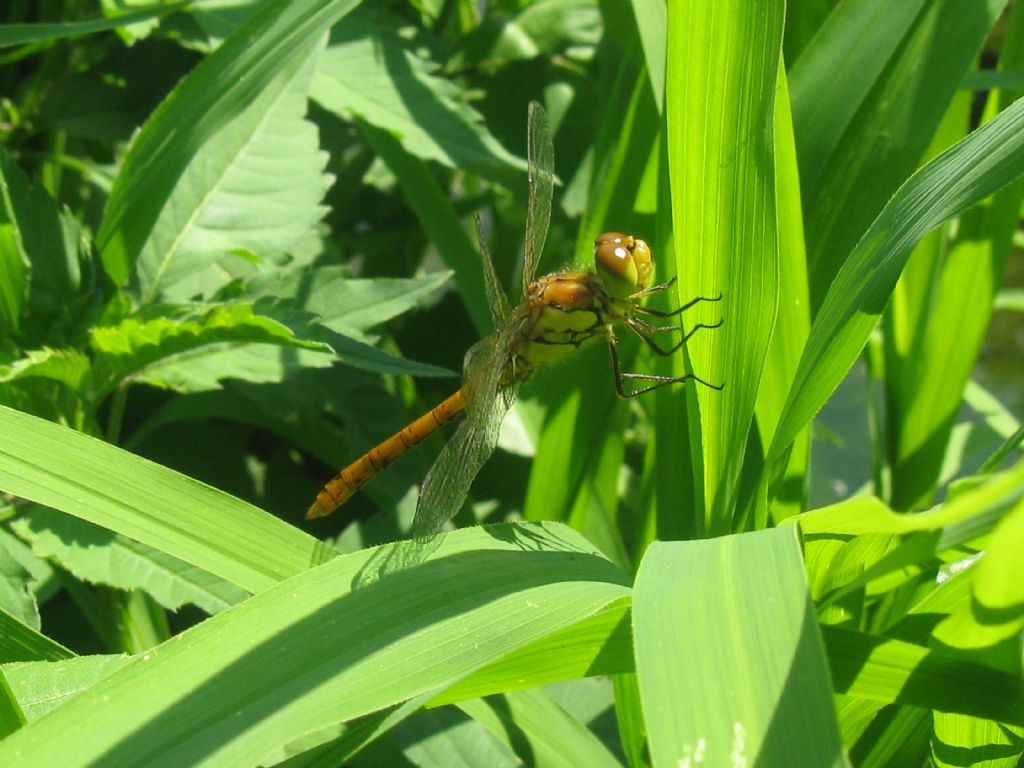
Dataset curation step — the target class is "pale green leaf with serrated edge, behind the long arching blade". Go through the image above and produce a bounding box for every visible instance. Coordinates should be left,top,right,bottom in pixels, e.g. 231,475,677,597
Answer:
134,39,332,303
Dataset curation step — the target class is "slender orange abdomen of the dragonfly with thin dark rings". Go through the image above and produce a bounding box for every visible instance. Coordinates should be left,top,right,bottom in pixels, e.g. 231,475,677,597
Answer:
306,389,466,520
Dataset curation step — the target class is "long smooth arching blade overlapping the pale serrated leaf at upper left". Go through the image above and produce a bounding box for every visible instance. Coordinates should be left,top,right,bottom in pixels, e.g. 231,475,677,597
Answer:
97,0,355,287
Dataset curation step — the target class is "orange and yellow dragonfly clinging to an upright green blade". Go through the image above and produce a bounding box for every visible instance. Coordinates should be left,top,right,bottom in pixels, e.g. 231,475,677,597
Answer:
306,101,722,539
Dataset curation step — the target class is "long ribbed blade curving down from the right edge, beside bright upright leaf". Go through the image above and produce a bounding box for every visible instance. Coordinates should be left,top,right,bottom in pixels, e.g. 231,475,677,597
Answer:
770,90,1024,475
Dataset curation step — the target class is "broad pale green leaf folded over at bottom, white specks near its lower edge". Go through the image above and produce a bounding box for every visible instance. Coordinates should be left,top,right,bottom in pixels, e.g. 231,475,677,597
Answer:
633,528,846,767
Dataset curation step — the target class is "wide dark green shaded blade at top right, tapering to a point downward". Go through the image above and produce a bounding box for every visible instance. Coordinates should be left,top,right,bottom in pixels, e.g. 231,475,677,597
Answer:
794,0,1006,313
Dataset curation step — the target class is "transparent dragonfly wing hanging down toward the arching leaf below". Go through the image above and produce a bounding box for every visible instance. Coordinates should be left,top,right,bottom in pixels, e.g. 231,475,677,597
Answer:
413,334,515,540
